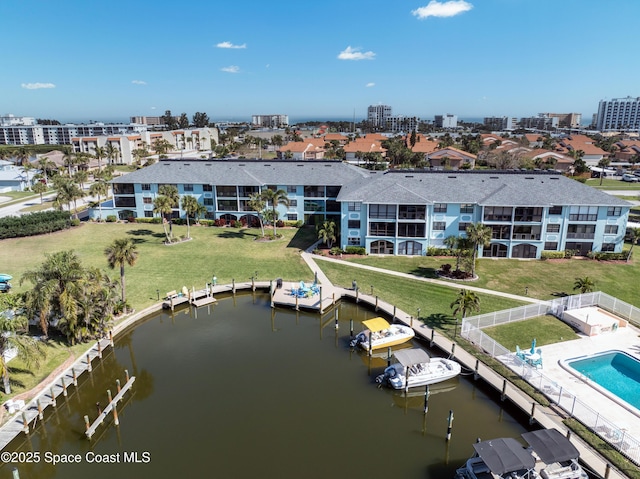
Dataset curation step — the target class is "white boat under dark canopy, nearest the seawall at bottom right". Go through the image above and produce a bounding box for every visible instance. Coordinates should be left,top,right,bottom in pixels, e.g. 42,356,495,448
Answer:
522,429,589,479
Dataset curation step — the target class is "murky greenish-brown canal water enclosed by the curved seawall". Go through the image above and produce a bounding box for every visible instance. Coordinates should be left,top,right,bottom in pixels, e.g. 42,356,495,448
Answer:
0,293,525,479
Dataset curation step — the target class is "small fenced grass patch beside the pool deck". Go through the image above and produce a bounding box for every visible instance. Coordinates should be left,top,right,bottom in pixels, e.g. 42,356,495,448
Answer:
482,315,579,351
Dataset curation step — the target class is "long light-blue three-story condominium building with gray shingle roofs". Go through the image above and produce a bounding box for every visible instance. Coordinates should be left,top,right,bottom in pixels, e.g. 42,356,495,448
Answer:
103,160,631,258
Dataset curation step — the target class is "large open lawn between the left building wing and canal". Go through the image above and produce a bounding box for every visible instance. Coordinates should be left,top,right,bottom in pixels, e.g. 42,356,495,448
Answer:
0,223,315,309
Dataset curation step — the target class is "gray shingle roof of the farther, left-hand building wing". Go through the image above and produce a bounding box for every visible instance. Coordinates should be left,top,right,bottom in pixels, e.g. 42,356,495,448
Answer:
113,160,369,186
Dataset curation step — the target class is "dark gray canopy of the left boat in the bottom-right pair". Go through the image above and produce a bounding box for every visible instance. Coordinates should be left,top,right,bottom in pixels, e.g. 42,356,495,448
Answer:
473,437,536,475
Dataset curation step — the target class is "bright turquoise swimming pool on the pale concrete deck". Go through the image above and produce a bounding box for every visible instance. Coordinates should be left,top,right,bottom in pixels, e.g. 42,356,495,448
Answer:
566,351,640,409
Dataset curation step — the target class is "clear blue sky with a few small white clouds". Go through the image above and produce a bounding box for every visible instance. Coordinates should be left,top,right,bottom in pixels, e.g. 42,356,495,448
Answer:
0,0,640,121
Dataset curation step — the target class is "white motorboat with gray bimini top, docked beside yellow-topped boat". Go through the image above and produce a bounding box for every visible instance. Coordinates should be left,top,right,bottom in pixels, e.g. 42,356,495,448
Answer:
376,348,462,389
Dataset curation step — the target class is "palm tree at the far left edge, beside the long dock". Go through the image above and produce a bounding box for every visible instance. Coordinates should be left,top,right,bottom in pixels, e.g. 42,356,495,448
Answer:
0,294,44,394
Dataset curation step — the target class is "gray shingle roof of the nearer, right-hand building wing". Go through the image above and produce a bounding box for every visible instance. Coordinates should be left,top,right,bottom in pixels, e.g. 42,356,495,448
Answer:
338,170,630,206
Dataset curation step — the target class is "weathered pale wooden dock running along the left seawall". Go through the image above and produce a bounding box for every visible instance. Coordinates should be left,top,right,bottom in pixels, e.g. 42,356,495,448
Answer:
0,337,113,450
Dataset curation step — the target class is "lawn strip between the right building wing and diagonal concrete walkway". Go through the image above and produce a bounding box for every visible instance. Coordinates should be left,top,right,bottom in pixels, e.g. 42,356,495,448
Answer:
338,255,640,307
